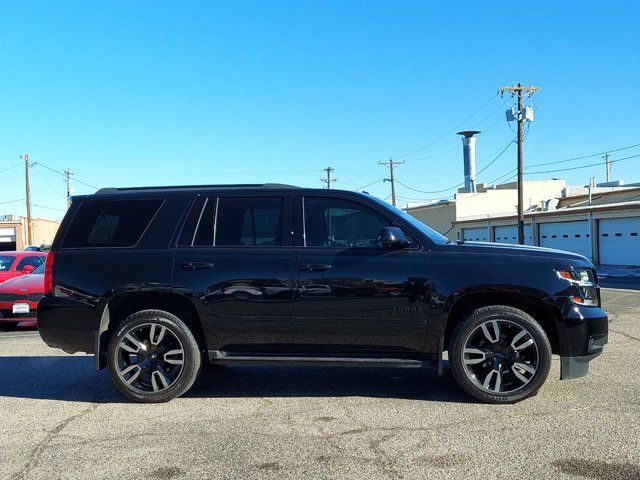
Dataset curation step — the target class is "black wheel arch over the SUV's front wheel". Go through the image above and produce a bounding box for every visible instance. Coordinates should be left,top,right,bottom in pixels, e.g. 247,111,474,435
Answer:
444,291,559,353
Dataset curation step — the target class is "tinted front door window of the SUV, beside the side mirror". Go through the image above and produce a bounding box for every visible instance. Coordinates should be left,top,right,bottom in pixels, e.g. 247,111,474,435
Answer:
304,198,393,248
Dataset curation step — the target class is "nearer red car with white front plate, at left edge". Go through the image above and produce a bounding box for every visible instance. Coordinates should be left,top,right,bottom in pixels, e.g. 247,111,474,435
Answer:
0,264,44,329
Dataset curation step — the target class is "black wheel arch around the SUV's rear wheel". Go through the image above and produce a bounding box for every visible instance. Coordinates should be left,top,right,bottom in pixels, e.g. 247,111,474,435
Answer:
94,292,206,370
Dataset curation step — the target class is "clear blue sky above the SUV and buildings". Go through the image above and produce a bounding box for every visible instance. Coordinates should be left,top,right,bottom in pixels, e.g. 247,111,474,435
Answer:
0,1,640,218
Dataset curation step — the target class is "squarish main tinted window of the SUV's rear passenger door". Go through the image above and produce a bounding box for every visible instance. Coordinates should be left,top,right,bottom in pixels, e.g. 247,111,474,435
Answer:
215,197,282,246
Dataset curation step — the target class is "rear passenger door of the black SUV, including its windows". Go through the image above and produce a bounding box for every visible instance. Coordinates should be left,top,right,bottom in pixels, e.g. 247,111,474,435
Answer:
173,193,293,354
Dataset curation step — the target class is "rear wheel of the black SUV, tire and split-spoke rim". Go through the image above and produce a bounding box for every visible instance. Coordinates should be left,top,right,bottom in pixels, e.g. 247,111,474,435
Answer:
107,310,202,403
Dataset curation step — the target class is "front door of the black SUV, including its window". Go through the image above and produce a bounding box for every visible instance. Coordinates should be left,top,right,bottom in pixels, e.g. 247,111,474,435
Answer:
293,195,429,356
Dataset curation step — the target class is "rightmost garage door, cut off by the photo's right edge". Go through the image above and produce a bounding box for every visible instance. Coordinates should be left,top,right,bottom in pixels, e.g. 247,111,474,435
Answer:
598,217,640,265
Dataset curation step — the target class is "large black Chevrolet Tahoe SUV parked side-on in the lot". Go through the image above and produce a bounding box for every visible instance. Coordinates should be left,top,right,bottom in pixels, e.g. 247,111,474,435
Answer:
38,184,607,403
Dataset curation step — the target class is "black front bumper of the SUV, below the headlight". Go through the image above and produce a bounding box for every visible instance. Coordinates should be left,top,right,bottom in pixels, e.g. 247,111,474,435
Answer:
558,303,609,380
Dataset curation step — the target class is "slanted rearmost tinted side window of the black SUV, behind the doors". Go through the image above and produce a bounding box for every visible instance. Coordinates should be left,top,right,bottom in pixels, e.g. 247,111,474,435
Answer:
62,199,163,248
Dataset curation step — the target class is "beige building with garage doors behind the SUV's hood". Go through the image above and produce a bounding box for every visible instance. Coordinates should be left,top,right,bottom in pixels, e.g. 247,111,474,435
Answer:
407,180,640,265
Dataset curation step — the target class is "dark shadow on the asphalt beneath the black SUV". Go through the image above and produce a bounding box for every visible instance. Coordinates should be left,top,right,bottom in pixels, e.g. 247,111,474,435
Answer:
0,355,473,403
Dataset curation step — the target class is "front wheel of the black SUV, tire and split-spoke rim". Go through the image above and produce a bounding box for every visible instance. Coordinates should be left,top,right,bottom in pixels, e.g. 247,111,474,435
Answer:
449,305,551,403
